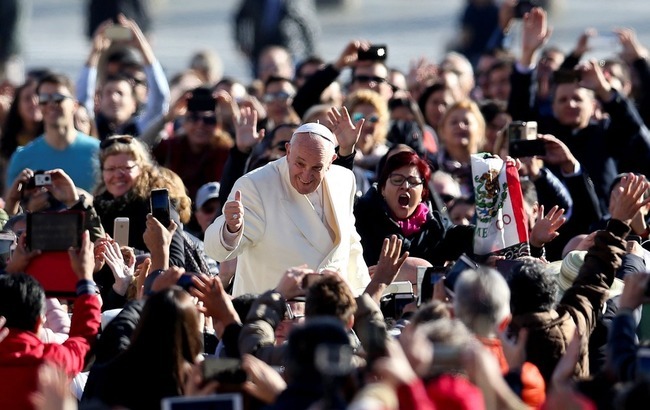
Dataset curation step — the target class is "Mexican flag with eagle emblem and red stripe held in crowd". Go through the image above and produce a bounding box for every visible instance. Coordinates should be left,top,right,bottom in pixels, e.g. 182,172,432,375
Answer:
471,153,530,259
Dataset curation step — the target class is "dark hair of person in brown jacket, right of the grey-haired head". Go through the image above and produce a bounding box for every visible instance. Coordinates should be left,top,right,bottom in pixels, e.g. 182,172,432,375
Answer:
508,259,558,315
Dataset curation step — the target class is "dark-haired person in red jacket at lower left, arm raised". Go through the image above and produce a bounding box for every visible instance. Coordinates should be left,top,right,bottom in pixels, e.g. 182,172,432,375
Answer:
0,232,101,409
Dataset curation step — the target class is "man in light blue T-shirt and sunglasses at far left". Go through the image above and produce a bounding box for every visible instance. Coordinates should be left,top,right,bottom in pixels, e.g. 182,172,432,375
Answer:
5,74,99,192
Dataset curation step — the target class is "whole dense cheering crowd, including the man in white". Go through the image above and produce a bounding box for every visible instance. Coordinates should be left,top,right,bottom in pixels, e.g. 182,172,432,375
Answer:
0,1,650,410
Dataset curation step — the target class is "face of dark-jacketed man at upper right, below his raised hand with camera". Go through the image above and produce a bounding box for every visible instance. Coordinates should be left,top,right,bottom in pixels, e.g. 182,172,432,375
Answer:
553,83,595,128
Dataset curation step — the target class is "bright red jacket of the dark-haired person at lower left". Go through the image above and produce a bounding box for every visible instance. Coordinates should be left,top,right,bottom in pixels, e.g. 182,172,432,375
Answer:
0,295,101,410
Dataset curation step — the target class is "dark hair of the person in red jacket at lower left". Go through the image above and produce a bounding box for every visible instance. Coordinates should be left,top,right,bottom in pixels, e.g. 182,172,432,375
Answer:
0,273,45,332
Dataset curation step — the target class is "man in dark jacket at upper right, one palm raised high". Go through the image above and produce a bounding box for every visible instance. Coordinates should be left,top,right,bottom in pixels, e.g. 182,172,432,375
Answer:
508,7,650,215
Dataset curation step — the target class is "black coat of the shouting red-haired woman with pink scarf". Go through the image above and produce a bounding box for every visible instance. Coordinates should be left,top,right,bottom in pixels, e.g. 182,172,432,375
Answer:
354,184,474,266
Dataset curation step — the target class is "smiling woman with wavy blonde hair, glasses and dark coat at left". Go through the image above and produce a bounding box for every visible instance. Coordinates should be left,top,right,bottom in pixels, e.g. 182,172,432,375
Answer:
94,135,185,287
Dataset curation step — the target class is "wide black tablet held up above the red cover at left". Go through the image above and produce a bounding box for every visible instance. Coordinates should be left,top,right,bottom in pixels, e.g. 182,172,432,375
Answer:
26,211,84,252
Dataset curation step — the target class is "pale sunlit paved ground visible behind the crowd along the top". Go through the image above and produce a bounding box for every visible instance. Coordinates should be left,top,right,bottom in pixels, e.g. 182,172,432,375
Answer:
19,0,650,84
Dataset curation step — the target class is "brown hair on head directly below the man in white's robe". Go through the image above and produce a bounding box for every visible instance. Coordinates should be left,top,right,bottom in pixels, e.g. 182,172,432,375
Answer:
305,275,357,324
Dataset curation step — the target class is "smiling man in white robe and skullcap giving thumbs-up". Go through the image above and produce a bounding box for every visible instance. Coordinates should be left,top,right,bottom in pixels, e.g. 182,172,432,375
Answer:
205,123,370,296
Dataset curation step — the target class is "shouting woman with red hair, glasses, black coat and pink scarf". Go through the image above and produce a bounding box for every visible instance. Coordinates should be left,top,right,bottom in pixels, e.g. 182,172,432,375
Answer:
354,149,474,270
